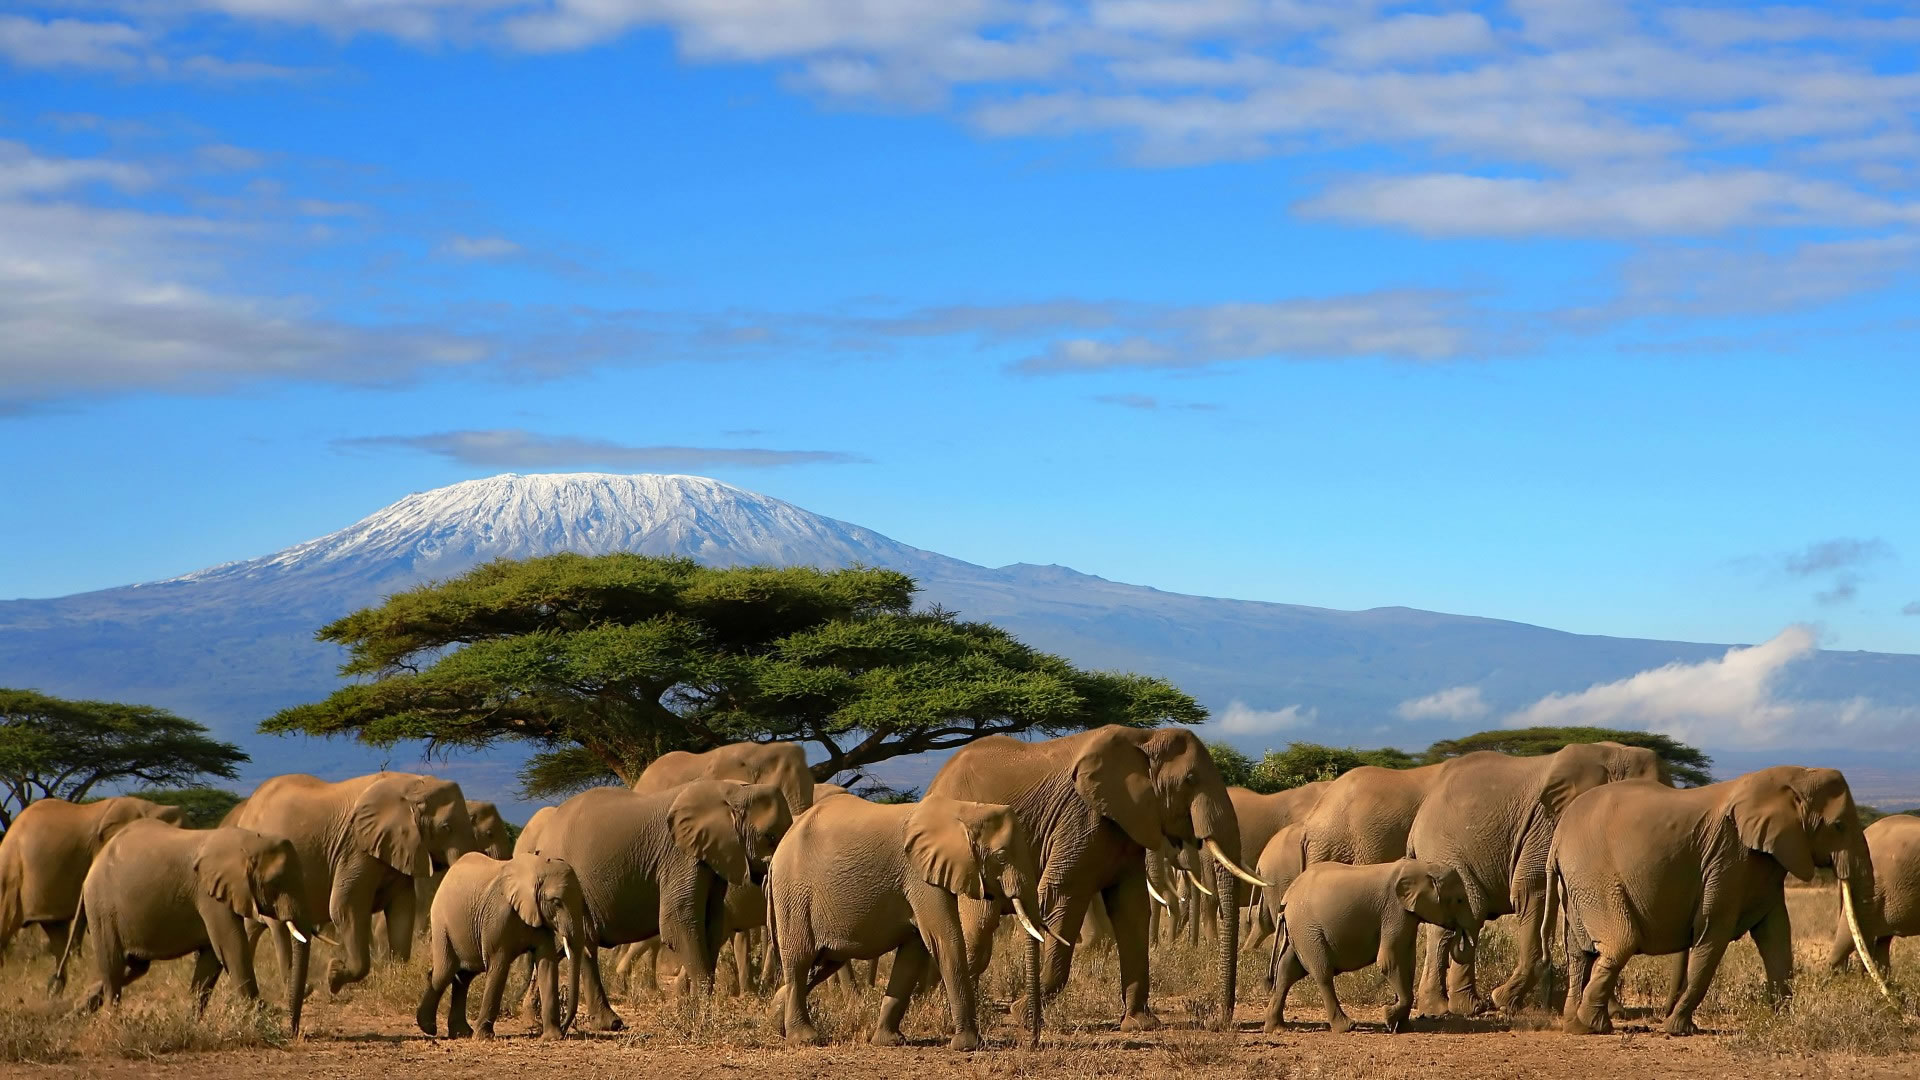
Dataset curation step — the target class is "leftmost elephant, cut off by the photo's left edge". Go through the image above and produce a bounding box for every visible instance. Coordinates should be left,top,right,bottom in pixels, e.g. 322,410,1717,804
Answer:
0,796,186,963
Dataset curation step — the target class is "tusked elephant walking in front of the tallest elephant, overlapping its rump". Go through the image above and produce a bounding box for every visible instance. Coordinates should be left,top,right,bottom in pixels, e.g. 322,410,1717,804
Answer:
768,796,1043,1049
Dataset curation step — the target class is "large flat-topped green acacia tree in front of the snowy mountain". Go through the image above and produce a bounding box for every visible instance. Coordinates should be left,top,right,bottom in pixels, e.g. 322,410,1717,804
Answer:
261,553,1206,798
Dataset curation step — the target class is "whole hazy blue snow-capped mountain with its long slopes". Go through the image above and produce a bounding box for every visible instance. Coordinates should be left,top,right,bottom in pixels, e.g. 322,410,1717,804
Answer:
0,473,1920,801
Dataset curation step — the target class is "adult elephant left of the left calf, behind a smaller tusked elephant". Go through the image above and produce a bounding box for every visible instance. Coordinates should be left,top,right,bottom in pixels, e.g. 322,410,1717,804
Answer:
223,773,476,994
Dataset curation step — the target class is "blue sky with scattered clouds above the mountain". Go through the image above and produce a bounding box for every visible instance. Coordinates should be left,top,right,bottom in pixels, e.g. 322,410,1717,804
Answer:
0,0,1920,651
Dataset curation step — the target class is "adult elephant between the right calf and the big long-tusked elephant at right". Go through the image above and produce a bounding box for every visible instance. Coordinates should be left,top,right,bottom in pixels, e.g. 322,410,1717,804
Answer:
1407,742,1670,1015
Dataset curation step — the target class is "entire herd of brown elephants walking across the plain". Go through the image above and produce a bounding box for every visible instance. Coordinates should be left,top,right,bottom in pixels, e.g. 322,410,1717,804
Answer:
0,726,1920,1049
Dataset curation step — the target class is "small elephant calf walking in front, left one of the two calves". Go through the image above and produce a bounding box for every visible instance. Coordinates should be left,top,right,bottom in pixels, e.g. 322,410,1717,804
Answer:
415,851,593,1040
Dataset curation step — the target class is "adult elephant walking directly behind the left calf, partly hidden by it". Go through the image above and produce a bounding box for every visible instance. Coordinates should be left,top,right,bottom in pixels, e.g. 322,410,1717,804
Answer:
515,780,793,1030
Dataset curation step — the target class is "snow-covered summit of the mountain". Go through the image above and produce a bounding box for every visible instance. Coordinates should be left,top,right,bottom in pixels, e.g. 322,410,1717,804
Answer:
157,473,960,584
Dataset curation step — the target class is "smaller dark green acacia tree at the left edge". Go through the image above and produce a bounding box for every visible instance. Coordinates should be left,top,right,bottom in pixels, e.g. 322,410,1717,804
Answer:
0,690,248,828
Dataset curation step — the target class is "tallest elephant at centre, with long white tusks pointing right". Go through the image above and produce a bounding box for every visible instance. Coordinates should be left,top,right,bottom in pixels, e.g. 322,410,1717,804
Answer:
927,726,1258,1032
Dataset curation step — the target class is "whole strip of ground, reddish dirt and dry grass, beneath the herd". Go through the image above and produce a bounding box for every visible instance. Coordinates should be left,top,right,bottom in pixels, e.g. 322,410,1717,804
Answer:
0,886,1920,1080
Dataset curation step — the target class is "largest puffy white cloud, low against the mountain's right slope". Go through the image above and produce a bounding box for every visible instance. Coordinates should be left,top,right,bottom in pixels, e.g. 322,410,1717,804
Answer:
1505,626,1920,746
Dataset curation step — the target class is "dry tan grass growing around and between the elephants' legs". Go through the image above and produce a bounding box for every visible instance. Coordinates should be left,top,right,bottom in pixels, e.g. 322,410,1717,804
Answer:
0,890,1920,1080
